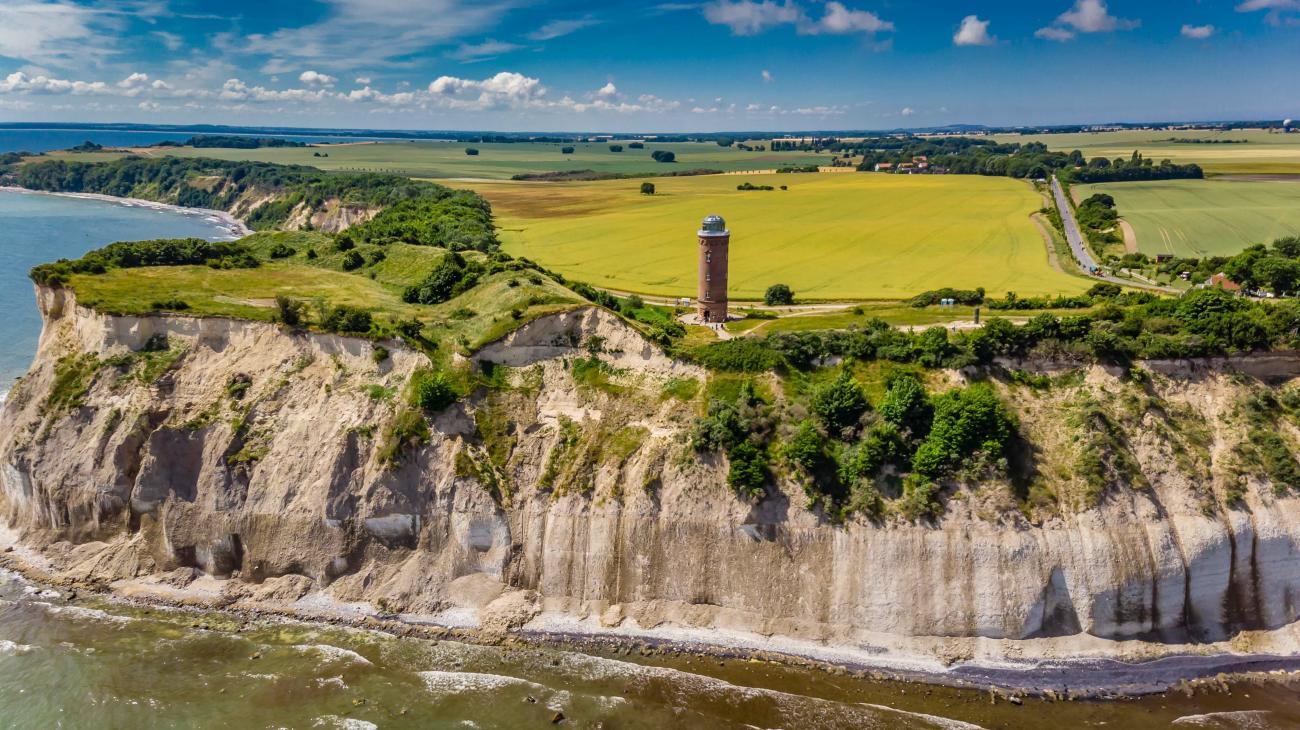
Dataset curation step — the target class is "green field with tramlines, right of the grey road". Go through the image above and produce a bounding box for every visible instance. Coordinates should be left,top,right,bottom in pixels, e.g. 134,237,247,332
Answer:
1075,179,1300,257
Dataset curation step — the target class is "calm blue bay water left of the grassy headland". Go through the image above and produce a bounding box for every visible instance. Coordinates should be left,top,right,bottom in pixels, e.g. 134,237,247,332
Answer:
0,190,229,395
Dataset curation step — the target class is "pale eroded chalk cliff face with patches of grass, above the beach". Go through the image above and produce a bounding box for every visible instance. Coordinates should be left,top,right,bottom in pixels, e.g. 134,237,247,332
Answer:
0,284,1300,660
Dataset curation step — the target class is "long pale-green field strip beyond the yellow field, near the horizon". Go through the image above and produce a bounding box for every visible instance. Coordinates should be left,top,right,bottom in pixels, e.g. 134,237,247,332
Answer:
55,142,831,179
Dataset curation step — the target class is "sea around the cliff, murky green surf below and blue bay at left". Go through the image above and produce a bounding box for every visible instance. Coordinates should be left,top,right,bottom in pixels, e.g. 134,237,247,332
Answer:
0,129,1300,730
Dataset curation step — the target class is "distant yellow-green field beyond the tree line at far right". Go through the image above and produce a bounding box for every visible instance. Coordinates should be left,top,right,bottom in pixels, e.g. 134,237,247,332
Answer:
995,130,1300,175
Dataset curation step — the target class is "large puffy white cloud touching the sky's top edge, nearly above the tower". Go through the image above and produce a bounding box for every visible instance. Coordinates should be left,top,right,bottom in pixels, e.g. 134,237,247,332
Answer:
703,0,894,35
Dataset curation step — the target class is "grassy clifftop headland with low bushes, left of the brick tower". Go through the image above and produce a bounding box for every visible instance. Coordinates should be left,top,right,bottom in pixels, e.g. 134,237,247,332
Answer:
72,233,584,352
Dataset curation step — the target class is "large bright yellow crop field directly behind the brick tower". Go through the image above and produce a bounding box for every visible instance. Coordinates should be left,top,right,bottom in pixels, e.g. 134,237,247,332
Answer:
469,173,1089,300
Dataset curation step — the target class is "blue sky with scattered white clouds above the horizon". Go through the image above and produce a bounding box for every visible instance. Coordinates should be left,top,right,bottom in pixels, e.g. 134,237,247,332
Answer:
0,0,1300,132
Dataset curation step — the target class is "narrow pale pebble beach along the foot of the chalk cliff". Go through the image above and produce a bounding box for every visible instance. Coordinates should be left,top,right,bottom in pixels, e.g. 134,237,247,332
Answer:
0,542,1300,701
